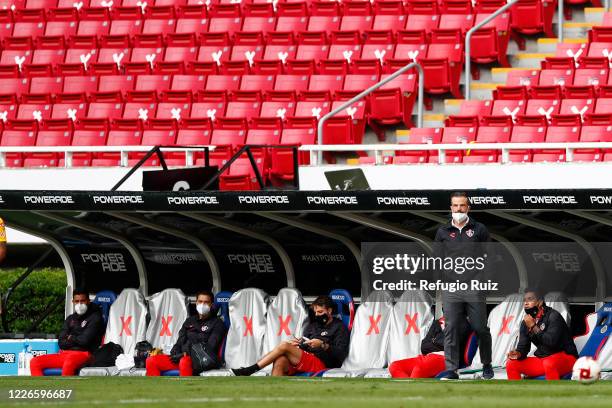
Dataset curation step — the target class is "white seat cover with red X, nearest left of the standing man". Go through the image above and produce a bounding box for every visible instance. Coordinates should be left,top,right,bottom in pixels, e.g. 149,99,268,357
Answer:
387,290,434,363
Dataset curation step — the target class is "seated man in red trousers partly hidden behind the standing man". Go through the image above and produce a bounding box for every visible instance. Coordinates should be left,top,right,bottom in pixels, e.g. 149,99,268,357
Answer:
389,318,470,378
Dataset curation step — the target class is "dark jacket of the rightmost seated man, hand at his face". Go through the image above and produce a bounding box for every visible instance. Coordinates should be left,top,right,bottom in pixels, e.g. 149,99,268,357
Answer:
516,305,578,360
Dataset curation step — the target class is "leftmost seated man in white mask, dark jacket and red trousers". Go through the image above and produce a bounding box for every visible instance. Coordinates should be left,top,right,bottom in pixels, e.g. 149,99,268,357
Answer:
30,290,105,376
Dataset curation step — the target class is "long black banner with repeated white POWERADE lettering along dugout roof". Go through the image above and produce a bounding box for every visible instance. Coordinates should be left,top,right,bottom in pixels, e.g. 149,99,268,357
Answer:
0,189,612,212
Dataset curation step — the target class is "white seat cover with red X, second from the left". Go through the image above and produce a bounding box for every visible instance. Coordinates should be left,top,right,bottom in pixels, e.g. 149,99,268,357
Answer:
147,289,188,353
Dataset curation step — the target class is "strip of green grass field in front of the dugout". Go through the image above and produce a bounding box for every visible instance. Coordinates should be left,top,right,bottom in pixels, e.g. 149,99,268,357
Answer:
0,377,612,408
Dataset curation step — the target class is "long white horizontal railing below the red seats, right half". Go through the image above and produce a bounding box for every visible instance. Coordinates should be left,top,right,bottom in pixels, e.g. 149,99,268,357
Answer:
299,142,612,166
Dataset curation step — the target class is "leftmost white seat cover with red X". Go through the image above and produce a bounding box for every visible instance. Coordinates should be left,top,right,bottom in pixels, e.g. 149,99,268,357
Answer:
104,289,147,355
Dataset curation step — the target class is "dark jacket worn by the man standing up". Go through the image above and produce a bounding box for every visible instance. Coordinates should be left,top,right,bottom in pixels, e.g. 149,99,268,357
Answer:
433,216,491,281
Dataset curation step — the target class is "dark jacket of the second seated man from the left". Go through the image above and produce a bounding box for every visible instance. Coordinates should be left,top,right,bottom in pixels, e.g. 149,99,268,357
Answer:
170,312,225,355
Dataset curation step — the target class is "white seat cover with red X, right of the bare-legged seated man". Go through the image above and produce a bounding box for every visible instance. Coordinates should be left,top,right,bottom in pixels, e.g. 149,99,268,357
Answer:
342,291,393,371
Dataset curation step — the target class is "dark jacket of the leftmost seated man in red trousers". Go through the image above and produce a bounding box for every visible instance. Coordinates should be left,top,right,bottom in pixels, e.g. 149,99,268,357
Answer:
58,303,106,352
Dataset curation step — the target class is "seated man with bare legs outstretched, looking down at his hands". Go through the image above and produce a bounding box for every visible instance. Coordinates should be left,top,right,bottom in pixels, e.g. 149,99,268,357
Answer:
232,296,349,376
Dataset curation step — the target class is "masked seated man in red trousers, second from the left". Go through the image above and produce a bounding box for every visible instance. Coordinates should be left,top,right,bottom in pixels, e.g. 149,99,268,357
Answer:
146,290,225,376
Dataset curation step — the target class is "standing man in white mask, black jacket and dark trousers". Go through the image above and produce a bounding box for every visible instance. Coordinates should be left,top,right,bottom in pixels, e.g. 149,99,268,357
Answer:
435,192,494,380
